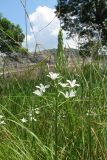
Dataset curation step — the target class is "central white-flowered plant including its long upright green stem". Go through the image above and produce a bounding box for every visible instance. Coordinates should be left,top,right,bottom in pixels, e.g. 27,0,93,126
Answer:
33,72,80,160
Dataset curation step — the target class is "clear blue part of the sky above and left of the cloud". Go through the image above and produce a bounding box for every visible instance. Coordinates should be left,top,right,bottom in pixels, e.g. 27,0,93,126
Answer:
0,0,57,31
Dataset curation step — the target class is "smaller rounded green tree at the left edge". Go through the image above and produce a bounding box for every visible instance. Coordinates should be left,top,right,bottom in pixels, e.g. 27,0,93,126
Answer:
0,16,25,52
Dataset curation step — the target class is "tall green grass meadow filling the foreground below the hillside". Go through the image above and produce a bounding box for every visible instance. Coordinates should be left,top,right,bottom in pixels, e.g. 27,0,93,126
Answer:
0,59,107,160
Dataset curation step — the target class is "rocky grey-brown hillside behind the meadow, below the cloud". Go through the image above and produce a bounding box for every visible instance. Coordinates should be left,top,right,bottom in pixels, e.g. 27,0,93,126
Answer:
0,49,79,68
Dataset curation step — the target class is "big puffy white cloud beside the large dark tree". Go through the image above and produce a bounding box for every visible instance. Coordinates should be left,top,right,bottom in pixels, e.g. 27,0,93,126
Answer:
23,6,76,51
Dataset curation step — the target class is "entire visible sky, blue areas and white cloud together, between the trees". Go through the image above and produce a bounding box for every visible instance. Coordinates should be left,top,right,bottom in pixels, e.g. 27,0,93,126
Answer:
0,0,76,51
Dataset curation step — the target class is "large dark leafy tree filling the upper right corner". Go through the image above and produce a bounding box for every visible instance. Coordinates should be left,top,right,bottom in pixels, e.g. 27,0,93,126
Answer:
56,0,107,57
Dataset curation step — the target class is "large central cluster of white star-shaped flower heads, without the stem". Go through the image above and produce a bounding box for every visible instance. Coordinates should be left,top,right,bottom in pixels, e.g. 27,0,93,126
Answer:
33,72,80,98
